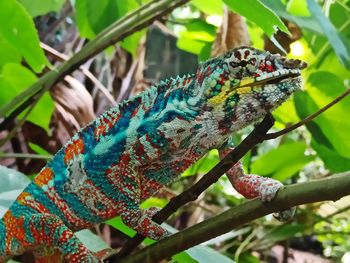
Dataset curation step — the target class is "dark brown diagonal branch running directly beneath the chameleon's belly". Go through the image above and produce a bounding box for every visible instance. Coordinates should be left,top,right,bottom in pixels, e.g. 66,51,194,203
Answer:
111,114,274,260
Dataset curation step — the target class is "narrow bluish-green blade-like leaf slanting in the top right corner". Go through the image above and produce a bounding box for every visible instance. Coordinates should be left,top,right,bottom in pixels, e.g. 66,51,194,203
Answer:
307,0,350,69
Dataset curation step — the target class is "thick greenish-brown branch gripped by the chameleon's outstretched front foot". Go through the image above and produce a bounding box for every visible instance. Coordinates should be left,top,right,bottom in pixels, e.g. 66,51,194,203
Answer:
118,172,350,263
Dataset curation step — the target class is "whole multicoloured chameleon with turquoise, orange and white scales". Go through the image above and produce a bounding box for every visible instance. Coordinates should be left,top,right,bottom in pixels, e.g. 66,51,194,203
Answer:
0,46,306,262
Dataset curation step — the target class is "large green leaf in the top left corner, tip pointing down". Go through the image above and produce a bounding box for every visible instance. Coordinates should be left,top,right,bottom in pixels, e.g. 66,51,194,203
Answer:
0,0,48,72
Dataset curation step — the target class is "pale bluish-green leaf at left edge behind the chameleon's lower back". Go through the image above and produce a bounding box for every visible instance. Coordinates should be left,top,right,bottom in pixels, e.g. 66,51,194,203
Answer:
0,165,30,218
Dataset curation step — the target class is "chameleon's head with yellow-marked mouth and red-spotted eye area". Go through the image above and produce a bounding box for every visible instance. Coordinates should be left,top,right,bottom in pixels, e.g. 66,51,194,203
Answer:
197,47,306,131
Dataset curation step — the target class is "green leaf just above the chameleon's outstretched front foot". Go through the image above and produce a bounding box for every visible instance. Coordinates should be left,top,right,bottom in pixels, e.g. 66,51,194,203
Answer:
251,142,313,181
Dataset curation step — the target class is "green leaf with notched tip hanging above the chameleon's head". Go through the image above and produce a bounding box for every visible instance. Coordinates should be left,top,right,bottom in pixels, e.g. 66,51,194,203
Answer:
224,0,289,38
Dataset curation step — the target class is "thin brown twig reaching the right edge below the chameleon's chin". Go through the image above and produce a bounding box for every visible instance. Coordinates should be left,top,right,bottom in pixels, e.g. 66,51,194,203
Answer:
265,89,350,140
